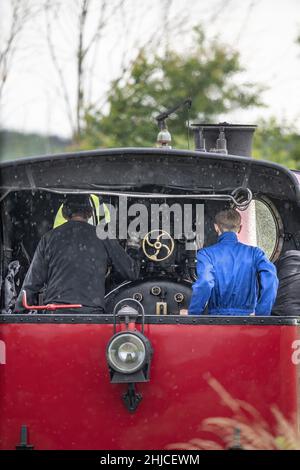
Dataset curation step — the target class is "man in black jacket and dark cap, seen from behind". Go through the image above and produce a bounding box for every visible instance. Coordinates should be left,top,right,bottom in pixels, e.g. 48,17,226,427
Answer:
15,195,139,313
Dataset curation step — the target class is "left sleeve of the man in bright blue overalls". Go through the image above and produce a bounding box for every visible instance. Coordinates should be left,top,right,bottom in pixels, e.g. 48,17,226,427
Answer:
189,250,215,315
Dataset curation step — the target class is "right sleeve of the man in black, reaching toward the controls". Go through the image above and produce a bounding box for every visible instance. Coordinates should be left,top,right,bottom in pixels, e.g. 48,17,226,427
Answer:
104,239,140,281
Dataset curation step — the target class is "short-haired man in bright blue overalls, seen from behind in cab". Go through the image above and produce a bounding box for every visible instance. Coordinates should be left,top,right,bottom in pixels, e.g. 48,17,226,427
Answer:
181,209,278,316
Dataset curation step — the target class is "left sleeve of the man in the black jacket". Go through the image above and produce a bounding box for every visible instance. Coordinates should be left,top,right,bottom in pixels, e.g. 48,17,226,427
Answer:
15,237,48,312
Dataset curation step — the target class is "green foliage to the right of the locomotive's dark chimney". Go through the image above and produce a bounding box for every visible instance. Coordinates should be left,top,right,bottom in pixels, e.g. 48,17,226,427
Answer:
253,118,300,170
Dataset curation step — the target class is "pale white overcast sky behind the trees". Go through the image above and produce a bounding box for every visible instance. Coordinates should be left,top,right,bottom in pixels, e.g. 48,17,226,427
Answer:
0,0,300,137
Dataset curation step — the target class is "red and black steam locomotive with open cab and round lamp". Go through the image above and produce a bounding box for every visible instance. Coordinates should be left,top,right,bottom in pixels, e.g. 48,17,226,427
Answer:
0,123,300,450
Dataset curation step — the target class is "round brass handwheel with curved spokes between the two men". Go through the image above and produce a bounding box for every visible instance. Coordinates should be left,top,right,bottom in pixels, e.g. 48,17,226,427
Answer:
142,230,174,262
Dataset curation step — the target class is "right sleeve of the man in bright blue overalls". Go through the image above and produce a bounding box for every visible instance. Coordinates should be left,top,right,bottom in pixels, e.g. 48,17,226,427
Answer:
255,250,278,315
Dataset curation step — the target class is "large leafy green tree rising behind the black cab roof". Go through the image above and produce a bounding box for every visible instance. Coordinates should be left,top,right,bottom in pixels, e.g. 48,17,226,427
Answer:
81,28,263,148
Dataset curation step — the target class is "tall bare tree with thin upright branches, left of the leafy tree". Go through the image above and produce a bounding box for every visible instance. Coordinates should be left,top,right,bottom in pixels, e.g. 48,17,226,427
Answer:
45,0,125,140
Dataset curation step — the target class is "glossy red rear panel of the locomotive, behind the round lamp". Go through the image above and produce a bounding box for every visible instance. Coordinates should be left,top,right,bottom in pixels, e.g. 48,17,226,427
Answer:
0,323,297,450
